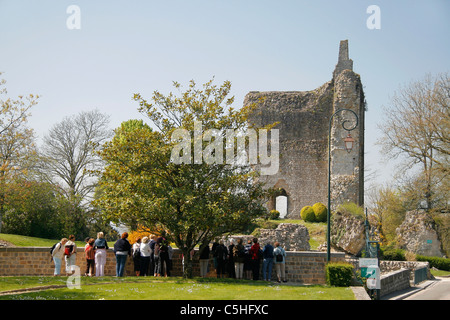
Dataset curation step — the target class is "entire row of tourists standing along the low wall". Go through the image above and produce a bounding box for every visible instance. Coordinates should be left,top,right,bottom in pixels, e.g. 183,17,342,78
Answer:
50,232,286,282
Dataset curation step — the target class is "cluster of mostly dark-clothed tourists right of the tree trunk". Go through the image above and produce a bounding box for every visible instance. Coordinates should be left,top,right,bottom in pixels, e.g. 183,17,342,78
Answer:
200,238,286,282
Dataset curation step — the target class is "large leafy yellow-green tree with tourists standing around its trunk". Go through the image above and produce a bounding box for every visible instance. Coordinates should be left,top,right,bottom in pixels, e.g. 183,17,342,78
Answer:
97,80,265,277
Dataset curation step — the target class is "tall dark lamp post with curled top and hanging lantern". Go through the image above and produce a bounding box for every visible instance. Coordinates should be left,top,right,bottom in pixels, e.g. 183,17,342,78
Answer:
327,108,359,263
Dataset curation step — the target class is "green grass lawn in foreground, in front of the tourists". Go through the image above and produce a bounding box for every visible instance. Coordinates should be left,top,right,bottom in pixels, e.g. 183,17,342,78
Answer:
0,277,355,300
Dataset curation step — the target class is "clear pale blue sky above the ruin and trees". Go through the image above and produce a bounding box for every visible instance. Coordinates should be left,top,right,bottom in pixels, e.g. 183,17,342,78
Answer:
0,0,450,192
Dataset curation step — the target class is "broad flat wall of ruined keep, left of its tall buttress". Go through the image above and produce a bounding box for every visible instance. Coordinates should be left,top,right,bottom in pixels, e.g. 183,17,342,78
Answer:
244,82,333,218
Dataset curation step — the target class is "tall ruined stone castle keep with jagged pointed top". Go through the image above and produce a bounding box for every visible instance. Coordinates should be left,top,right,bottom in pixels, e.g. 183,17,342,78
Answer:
244,40,365,218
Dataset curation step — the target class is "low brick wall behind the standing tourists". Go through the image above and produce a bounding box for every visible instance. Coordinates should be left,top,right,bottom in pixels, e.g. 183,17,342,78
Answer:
0,247,345,284
